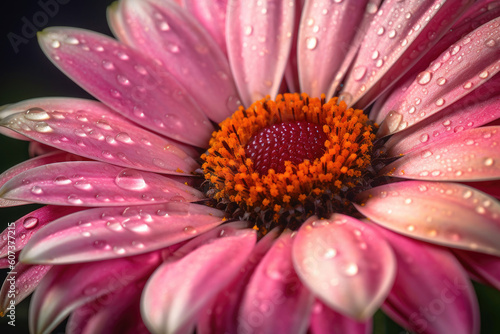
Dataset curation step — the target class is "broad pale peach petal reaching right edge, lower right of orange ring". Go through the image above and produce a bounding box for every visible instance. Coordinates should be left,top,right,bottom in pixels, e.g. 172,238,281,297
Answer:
355,181,500,255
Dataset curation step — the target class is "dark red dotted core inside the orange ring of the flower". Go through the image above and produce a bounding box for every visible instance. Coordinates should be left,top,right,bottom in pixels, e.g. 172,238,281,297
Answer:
245,121,328,175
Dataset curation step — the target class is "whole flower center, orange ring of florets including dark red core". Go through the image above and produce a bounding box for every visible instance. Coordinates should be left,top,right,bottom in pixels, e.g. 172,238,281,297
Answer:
201,93,375,230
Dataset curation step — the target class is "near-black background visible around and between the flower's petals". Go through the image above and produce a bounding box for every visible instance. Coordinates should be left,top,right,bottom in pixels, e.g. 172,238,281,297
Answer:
0,0,500,334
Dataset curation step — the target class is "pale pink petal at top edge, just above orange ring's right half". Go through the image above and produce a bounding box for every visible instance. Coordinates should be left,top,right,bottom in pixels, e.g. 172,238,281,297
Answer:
297,0,368,97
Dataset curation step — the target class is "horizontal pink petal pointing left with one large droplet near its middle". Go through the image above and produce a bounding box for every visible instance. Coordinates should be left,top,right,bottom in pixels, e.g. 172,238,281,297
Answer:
0,161,203,206
